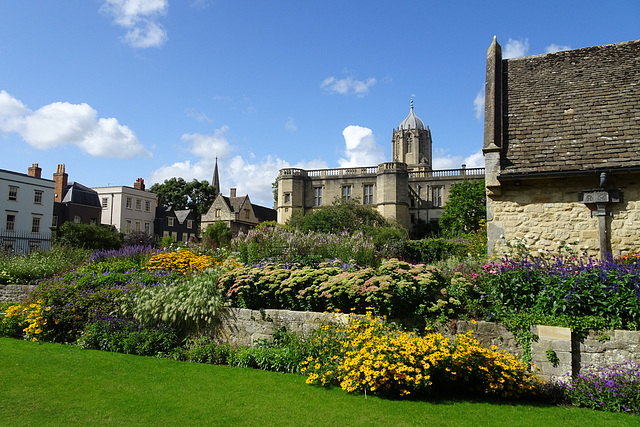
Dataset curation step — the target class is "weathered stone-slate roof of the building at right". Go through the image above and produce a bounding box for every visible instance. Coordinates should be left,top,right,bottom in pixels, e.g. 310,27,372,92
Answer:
501,40,640,175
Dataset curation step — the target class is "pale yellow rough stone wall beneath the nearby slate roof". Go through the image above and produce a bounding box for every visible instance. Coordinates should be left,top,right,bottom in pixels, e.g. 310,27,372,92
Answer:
487,173,640,257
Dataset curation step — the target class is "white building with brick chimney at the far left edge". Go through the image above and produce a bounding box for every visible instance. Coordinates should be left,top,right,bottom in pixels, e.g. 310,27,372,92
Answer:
0,164,55,253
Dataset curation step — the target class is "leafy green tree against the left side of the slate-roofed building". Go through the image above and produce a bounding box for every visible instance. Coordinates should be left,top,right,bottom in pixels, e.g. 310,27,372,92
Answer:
440,180,487,237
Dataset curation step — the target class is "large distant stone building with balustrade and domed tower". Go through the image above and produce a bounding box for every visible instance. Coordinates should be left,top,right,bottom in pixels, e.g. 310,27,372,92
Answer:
277,102,484,229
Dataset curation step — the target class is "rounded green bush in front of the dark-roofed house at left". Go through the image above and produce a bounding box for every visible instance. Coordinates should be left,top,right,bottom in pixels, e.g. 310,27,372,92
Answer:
54,222,122,249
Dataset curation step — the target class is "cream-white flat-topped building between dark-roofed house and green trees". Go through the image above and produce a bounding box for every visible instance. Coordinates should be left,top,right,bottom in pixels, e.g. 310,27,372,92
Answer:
93,178,156,236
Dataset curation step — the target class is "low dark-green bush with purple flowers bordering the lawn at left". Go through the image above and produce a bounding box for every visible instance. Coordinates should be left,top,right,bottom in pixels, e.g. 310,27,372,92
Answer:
78,316,180,356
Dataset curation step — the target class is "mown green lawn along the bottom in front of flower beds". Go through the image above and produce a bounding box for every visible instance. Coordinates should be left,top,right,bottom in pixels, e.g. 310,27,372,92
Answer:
0,338,640,427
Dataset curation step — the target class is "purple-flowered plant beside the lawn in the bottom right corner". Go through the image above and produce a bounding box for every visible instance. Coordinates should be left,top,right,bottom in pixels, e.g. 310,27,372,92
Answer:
565,362,640,414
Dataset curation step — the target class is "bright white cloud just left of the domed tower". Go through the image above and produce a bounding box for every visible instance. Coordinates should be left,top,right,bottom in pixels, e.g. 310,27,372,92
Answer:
338,125,385,168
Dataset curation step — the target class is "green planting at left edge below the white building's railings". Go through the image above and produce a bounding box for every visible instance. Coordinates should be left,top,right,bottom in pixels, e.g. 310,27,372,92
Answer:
0,247,90,285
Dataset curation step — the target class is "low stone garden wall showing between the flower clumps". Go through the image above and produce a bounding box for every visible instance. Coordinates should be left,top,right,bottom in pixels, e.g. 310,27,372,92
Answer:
212,308,640,376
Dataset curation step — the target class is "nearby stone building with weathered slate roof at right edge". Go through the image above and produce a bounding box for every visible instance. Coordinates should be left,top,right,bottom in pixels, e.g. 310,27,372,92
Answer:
483,38,640,257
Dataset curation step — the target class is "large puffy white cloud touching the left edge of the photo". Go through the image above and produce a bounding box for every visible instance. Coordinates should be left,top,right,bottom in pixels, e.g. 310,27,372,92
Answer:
0,90,151,158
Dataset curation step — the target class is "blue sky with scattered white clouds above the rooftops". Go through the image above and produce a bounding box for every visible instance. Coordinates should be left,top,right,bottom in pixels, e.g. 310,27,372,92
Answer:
0,0,640,206
